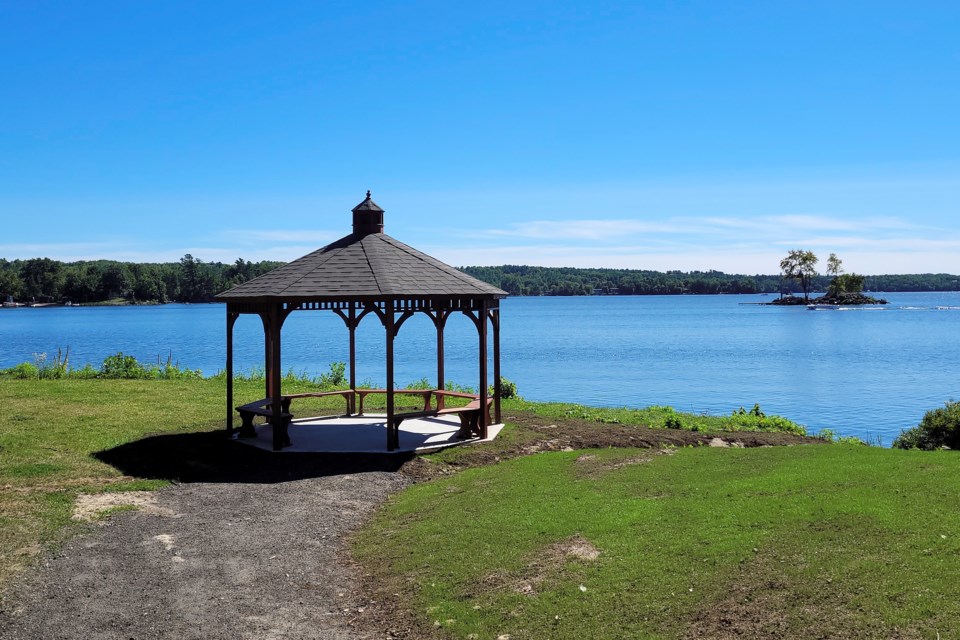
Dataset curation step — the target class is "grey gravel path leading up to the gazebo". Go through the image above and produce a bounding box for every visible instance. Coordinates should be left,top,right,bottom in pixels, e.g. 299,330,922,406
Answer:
0,471,409,640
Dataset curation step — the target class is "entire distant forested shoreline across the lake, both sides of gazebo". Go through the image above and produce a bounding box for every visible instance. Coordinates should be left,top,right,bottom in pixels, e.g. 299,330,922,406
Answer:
0,254,960,303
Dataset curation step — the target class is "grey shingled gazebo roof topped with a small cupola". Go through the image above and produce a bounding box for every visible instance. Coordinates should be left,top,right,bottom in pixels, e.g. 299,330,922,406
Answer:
216,191,507,302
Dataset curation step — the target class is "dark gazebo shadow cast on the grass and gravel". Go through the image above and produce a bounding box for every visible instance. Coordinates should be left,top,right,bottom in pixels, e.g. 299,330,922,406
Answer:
93,430,414,483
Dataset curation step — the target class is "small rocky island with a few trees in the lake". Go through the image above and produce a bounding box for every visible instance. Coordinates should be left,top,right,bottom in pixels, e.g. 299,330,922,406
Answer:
766,249,887,308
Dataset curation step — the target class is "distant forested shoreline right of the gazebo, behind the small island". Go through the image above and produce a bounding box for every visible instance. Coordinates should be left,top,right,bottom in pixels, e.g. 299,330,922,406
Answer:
463,265,960,296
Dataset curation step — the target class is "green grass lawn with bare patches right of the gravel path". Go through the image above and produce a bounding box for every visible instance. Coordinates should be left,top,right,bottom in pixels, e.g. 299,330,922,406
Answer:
355,445,960,640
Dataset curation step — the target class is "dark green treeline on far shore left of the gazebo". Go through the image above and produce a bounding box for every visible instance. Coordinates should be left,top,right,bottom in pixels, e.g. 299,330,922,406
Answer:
0,254,283,303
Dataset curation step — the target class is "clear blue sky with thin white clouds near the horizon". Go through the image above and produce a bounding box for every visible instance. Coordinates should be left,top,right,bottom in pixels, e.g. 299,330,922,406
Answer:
0,0,960,274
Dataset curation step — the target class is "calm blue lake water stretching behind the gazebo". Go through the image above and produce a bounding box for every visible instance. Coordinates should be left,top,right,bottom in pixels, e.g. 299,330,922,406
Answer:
0,292,960,445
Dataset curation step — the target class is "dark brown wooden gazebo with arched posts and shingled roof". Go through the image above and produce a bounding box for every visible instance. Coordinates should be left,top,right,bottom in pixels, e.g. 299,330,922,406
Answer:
215,191,507,451
